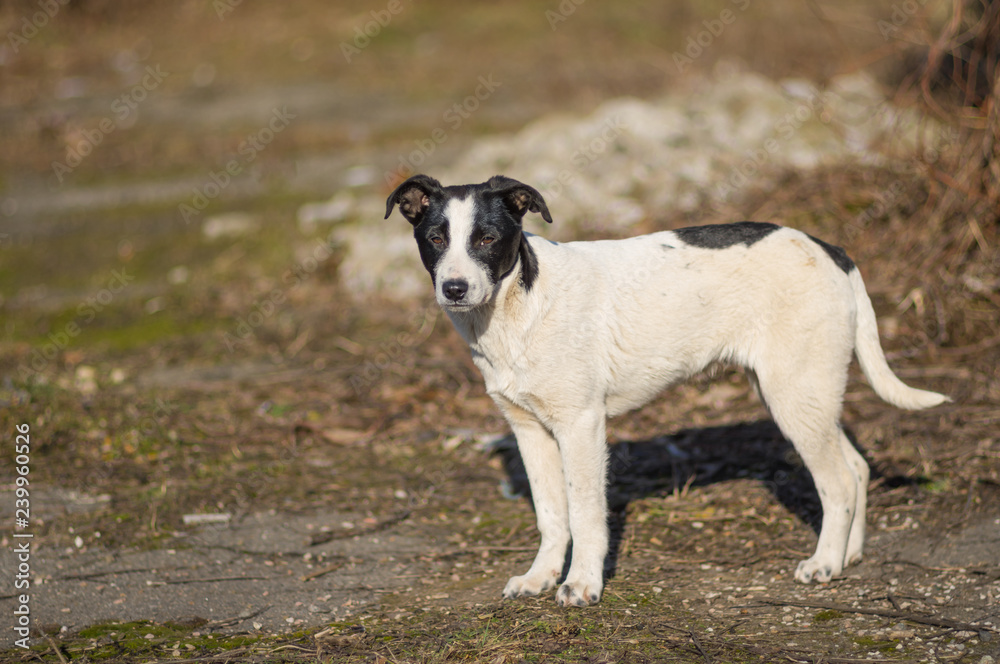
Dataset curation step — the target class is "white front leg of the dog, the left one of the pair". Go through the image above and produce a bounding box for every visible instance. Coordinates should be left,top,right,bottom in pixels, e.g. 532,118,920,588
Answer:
497,399,569,599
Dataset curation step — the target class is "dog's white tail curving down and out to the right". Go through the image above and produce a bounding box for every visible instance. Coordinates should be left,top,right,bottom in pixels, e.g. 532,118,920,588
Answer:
848,267,951,410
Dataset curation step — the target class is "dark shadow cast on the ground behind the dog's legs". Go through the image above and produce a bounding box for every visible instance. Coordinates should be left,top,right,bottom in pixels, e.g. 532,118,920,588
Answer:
493,420,854,576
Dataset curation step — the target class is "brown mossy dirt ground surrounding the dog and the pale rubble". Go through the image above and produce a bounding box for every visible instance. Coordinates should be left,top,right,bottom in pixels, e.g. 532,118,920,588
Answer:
0,0,1000,664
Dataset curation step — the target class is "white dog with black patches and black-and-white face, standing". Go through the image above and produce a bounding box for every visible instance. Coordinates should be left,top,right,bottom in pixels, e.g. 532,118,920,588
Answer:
386,175,947,606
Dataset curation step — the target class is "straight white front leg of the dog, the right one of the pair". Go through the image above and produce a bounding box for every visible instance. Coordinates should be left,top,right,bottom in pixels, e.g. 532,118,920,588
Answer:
555,409,608,606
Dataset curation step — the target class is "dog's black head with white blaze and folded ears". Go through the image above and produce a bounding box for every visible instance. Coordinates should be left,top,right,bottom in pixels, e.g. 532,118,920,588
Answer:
385,175,552,311
